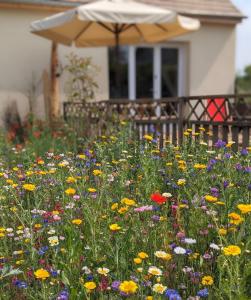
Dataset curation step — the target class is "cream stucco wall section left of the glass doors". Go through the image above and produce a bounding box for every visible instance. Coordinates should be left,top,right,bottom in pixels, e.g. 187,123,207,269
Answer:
0,9,108,125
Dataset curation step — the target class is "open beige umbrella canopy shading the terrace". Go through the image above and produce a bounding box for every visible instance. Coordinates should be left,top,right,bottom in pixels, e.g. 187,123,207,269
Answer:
31,0,200,47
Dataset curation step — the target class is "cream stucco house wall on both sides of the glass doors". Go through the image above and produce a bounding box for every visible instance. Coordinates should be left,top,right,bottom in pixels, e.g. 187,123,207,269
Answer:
0,9,235,124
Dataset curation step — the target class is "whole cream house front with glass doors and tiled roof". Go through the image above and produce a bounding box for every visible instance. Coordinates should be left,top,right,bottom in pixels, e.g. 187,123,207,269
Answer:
0,0,243,124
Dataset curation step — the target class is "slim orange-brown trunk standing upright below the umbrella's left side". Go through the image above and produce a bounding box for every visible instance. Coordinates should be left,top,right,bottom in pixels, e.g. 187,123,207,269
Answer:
50,42,60,123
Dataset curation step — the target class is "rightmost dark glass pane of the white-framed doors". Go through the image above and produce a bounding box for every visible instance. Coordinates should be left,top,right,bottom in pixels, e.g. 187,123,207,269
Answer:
161,48,178,98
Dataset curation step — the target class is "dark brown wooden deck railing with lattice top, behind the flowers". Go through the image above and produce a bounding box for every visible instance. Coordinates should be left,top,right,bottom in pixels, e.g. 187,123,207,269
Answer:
64,95,251,149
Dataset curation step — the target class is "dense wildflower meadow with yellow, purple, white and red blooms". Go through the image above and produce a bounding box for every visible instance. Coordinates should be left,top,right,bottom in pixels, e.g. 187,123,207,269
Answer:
0,122,251,300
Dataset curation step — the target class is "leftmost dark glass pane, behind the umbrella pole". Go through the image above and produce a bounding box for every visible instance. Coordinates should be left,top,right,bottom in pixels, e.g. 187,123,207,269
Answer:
109,46,128,99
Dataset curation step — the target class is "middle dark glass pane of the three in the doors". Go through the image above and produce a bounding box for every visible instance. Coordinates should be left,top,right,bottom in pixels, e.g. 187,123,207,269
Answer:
136,48,153,98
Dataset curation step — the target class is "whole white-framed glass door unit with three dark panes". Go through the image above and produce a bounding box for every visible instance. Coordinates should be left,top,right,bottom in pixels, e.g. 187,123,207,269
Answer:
109,45,185,100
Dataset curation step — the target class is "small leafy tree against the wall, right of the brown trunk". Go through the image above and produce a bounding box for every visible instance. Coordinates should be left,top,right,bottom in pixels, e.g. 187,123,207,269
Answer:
64,53,99,102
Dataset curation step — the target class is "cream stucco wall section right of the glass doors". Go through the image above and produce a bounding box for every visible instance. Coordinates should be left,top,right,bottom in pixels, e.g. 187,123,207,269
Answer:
176,23,236,95
